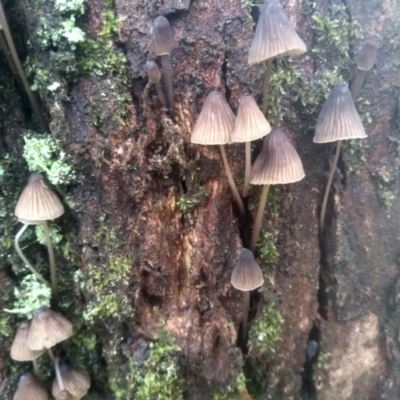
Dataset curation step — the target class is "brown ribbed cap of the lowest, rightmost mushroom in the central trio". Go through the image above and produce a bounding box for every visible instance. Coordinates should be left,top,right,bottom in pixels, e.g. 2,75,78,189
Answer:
250,128,305,185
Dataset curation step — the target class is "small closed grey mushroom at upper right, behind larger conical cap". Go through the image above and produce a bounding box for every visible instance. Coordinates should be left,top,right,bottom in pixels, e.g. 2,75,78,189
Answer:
350,35,380,101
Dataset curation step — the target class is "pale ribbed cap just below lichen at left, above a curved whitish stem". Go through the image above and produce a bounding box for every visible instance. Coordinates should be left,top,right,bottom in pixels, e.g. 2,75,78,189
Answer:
14,173,64,224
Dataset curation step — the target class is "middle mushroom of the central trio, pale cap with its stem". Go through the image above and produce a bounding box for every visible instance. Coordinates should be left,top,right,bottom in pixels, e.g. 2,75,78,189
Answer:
231,96,271,197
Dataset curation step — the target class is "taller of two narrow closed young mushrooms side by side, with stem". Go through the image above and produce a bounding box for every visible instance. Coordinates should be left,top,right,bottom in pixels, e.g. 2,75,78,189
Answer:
153,16,174,118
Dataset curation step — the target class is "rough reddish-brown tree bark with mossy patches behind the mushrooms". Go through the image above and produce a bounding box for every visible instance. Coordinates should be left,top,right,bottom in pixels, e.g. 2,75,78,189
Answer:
0,0,400,400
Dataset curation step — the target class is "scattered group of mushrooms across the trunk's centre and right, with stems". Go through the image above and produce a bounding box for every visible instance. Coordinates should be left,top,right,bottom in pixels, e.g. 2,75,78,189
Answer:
146,0,379,341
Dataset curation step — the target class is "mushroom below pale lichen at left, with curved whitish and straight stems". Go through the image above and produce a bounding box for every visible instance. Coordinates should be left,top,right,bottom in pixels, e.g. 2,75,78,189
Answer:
14,173,64,295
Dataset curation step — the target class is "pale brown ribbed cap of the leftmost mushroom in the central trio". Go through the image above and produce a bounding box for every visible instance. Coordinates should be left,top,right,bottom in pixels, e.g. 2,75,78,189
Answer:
191,90,236,145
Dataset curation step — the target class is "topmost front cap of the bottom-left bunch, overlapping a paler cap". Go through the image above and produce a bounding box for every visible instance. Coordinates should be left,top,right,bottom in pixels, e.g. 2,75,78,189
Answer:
28,307,73,350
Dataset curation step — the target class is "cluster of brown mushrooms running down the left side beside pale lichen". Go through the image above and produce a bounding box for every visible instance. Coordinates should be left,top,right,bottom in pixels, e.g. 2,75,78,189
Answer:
11,173,90,400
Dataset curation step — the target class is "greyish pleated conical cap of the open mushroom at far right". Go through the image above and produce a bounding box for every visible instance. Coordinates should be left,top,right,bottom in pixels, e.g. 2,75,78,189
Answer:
314,82,367,143
